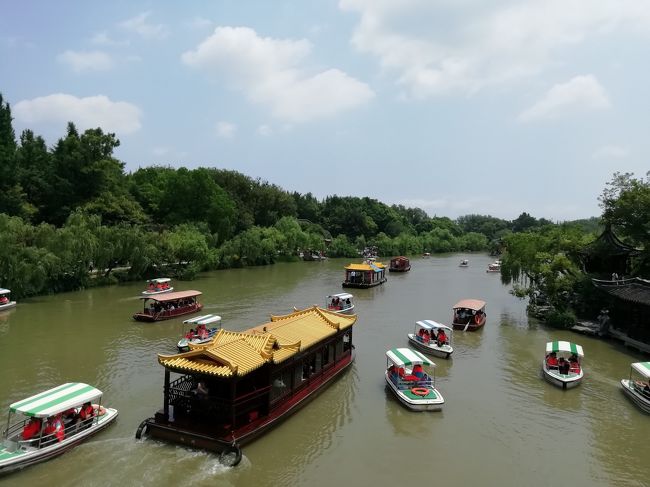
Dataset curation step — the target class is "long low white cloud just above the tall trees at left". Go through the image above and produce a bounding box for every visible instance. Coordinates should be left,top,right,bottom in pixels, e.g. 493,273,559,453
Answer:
12,93,141,135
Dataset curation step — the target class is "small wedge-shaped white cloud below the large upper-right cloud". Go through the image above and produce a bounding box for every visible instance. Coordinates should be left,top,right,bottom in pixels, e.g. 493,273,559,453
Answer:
519,75,610,122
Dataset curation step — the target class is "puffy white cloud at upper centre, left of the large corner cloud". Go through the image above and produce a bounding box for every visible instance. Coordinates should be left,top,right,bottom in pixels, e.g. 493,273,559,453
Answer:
182,27,374,122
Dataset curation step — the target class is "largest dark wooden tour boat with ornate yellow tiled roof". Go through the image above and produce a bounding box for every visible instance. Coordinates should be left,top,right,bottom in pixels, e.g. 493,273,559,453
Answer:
136,306,357,465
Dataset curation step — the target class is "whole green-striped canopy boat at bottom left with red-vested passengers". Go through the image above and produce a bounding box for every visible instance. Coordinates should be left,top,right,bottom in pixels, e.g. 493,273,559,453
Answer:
0,382,117,474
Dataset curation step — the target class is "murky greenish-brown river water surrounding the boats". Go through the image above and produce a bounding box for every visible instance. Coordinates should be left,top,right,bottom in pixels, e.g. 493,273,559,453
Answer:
0,254,650,487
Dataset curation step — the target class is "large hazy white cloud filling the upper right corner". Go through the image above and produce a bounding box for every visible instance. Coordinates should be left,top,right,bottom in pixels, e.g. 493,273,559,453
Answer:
339,0,650,98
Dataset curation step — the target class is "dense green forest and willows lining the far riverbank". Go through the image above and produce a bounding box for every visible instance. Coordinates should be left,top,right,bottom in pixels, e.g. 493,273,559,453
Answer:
0,95,650,316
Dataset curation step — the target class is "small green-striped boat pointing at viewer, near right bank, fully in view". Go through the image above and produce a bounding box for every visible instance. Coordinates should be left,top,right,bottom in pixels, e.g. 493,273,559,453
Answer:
542,341,585,389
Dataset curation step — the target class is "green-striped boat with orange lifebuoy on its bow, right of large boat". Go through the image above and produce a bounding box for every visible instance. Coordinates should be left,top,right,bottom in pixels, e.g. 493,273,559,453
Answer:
384,348,445,411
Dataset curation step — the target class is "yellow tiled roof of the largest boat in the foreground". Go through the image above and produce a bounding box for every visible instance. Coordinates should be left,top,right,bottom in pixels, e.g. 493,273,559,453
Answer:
158,306,357,377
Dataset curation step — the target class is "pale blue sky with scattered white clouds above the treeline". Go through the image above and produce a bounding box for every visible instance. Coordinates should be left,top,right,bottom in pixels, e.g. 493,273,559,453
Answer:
0,0,650,221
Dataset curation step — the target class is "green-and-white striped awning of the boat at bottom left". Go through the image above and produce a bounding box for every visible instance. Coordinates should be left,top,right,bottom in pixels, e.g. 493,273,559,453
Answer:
9,382,102,418
